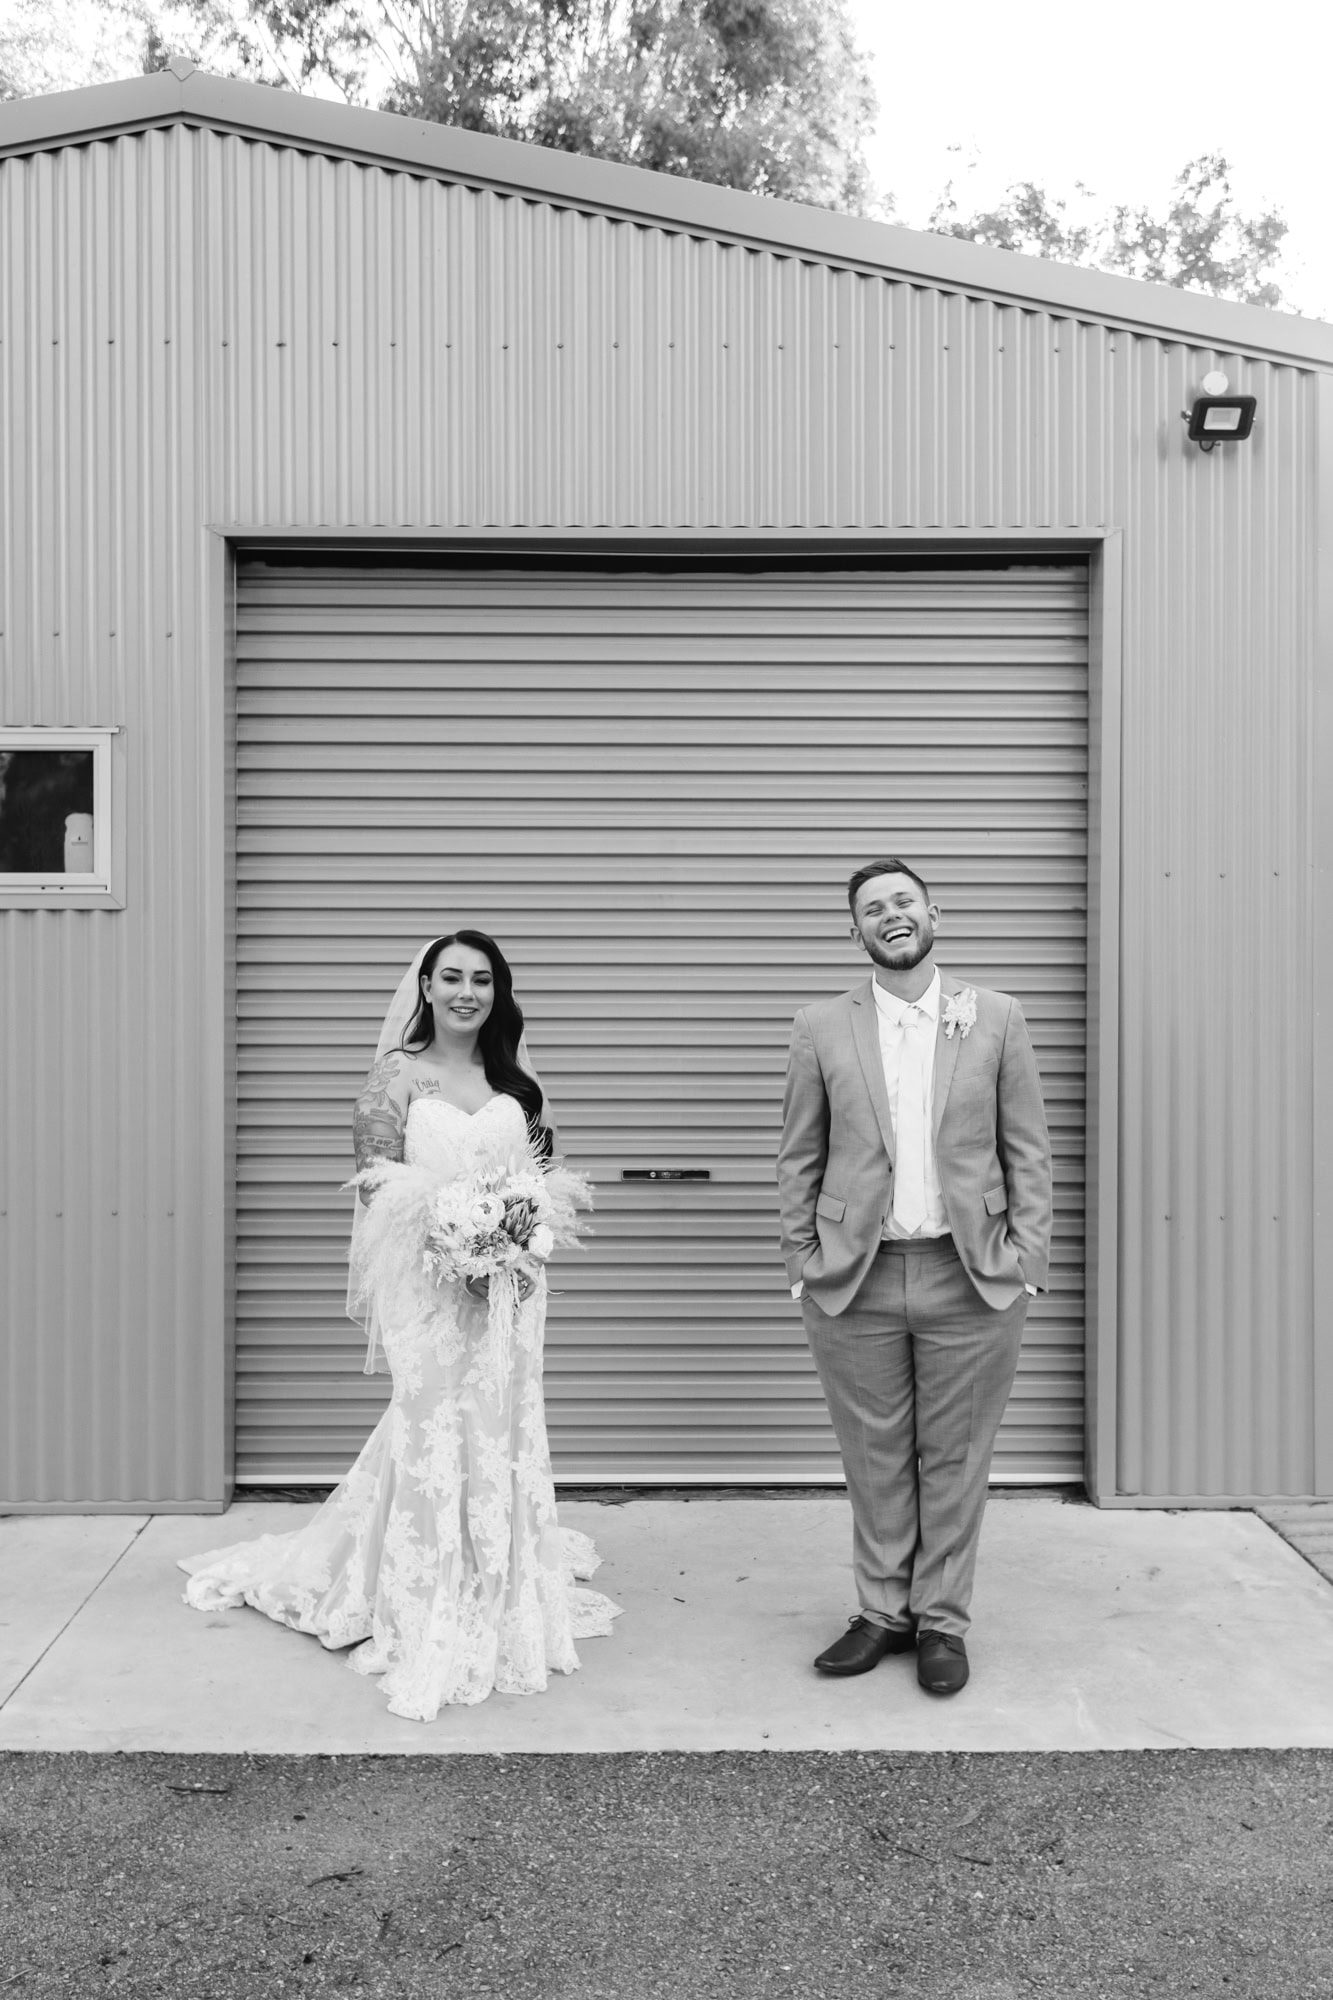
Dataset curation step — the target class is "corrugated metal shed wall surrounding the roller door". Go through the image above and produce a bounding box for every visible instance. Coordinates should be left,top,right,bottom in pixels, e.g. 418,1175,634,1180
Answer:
0,126,1315,1504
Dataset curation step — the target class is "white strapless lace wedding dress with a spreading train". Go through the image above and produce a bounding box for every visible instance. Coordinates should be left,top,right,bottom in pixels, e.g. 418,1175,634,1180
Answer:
180,1096,618,1722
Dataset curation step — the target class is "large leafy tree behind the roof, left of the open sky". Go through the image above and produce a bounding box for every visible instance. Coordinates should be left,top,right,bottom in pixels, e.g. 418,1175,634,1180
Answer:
127,0,875,210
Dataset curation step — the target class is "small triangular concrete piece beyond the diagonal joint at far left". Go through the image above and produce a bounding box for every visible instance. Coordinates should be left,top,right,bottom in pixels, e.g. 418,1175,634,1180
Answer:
0,1514,148,1706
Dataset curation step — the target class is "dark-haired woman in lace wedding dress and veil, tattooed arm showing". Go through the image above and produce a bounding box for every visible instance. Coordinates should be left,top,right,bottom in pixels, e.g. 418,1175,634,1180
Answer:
180,930,618,1722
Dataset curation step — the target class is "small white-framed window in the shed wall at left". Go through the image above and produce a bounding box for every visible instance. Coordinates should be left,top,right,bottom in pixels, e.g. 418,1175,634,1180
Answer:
0,728,116,906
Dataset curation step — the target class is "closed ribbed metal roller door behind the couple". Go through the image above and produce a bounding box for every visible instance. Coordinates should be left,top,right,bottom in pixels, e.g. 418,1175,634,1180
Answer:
236,560,1087,1484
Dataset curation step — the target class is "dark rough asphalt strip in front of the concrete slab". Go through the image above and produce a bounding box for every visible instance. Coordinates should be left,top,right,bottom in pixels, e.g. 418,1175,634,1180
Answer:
0,1750,1333,2000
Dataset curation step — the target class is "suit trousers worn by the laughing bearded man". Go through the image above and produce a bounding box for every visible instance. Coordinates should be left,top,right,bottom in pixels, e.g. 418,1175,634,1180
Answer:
801,1236,1027,1638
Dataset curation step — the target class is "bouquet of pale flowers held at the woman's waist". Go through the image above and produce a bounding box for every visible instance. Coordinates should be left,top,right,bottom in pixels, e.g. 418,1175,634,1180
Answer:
422,1158,592,1286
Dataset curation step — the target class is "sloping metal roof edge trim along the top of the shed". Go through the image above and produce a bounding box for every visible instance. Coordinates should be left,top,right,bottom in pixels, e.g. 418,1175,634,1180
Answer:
0,60,1333,368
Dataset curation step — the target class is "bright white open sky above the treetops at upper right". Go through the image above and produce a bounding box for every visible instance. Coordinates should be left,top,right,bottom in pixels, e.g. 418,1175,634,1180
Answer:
847,0,1333,320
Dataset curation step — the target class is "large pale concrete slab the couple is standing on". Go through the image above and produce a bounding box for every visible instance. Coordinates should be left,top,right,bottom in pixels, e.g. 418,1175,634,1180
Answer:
0,1494,1333,1754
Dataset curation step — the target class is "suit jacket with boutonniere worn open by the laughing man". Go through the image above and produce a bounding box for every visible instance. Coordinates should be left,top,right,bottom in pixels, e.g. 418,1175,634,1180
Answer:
777,968,1051,1316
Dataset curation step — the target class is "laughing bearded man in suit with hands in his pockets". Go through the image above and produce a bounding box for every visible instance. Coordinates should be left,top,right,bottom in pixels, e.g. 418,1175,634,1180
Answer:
777,860,1051,1694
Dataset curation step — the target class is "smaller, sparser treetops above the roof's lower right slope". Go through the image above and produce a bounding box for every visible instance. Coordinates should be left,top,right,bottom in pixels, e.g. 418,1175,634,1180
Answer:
929,152,1287,306
